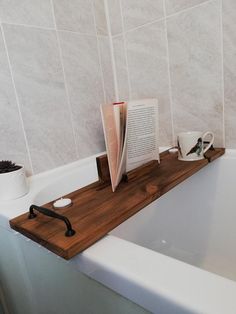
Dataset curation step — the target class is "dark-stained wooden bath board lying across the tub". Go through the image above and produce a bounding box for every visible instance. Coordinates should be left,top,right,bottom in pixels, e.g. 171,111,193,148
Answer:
10,148,225,259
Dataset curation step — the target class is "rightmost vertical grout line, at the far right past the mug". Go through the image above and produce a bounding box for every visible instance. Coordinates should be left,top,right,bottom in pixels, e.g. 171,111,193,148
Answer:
220,0,226,147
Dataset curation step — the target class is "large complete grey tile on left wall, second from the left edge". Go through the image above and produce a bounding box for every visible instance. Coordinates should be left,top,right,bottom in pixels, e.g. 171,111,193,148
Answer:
4,25,76,173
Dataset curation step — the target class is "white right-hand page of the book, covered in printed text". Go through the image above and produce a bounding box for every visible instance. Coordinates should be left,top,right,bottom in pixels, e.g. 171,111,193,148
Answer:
126,99,160,171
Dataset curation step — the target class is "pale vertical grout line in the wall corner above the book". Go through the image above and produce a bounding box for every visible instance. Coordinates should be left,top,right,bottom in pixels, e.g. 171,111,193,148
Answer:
104,0,120,101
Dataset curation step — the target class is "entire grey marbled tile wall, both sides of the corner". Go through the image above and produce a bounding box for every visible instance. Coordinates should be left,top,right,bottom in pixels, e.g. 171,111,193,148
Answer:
0,0,236,173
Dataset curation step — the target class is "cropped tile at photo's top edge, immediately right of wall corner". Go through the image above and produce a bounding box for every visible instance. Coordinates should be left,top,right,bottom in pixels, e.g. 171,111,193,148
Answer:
121,0,164,31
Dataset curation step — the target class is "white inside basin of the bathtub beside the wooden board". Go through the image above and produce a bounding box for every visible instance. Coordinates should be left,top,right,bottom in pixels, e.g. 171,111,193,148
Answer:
111,158,236,280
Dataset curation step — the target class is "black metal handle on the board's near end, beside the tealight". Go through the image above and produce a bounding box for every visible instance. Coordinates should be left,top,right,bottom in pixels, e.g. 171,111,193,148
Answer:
28,205,75,237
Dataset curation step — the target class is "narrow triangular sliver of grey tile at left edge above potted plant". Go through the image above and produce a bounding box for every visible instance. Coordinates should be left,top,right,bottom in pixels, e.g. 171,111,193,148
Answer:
0,28,32,174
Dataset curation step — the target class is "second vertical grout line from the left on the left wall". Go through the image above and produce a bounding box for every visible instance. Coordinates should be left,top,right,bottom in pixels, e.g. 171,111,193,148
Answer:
50,0,79,158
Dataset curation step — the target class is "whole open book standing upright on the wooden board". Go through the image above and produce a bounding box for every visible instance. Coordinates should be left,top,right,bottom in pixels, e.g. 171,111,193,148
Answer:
101,99,160,192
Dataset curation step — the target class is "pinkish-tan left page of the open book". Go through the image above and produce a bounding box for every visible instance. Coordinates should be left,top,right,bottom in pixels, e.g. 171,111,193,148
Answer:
101,105,119,191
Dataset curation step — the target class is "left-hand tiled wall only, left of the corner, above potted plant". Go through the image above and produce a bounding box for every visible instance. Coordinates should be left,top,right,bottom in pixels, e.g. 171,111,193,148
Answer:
0,0,114,174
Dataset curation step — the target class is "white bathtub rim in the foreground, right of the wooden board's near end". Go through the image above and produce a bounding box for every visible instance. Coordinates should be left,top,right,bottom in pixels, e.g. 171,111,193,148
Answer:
73,235,236,314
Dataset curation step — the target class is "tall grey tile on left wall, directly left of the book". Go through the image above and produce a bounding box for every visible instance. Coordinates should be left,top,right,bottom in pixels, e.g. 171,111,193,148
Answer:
60,31,105,158
